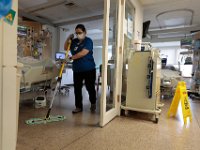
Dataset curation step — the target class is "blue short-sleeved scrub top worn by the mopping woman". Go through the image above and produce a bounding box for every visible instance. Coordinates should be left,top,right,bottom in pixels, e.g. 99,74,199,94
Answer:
70,37,95,72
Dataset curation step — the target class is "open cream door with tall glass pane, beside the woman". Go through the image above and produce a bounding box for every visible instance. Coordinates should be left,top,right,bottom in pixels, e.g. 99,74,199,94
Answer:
100,0,122,127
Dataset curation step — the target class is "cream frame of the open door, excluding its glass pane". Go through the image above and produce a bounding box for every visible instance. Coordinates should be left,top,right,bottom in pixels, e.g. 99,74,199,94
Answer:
100,0,125,127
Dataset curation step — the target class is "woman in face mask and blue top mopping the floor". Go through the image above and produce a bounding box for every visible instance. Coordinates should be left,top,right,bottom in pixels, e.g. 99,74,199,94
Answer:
64,24,96,114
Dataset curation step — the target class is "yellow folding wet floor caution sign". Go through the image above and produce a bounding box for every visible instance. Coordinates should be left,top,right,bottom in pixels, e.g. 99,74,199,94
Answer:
167,81,192,124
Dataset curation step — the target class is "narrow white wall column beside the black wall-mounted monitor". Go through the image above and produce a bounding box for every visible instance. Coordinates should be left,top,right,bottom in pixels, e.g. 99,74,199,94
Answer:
130,0,143,40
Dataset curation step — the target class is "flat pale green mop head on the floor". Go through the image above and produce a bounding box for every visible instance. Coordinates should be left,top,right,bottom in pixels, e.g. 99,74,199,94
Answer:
25,115,66,125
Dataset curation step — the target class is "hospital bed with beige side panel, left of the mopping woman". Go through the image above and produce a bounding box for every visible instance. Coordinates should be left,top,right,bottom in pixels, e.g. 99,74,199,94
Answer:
18,57,58,93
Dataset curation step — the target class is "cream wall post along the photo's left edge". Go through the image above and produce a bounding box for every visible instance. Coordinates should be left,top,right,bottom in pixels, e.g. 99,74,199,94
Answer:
0,0,19,150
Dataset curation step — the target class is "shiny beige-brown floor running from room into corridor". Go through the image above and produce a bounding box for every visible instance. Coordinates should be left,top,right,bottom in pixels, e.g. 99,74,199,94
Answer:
17,86,200,150
